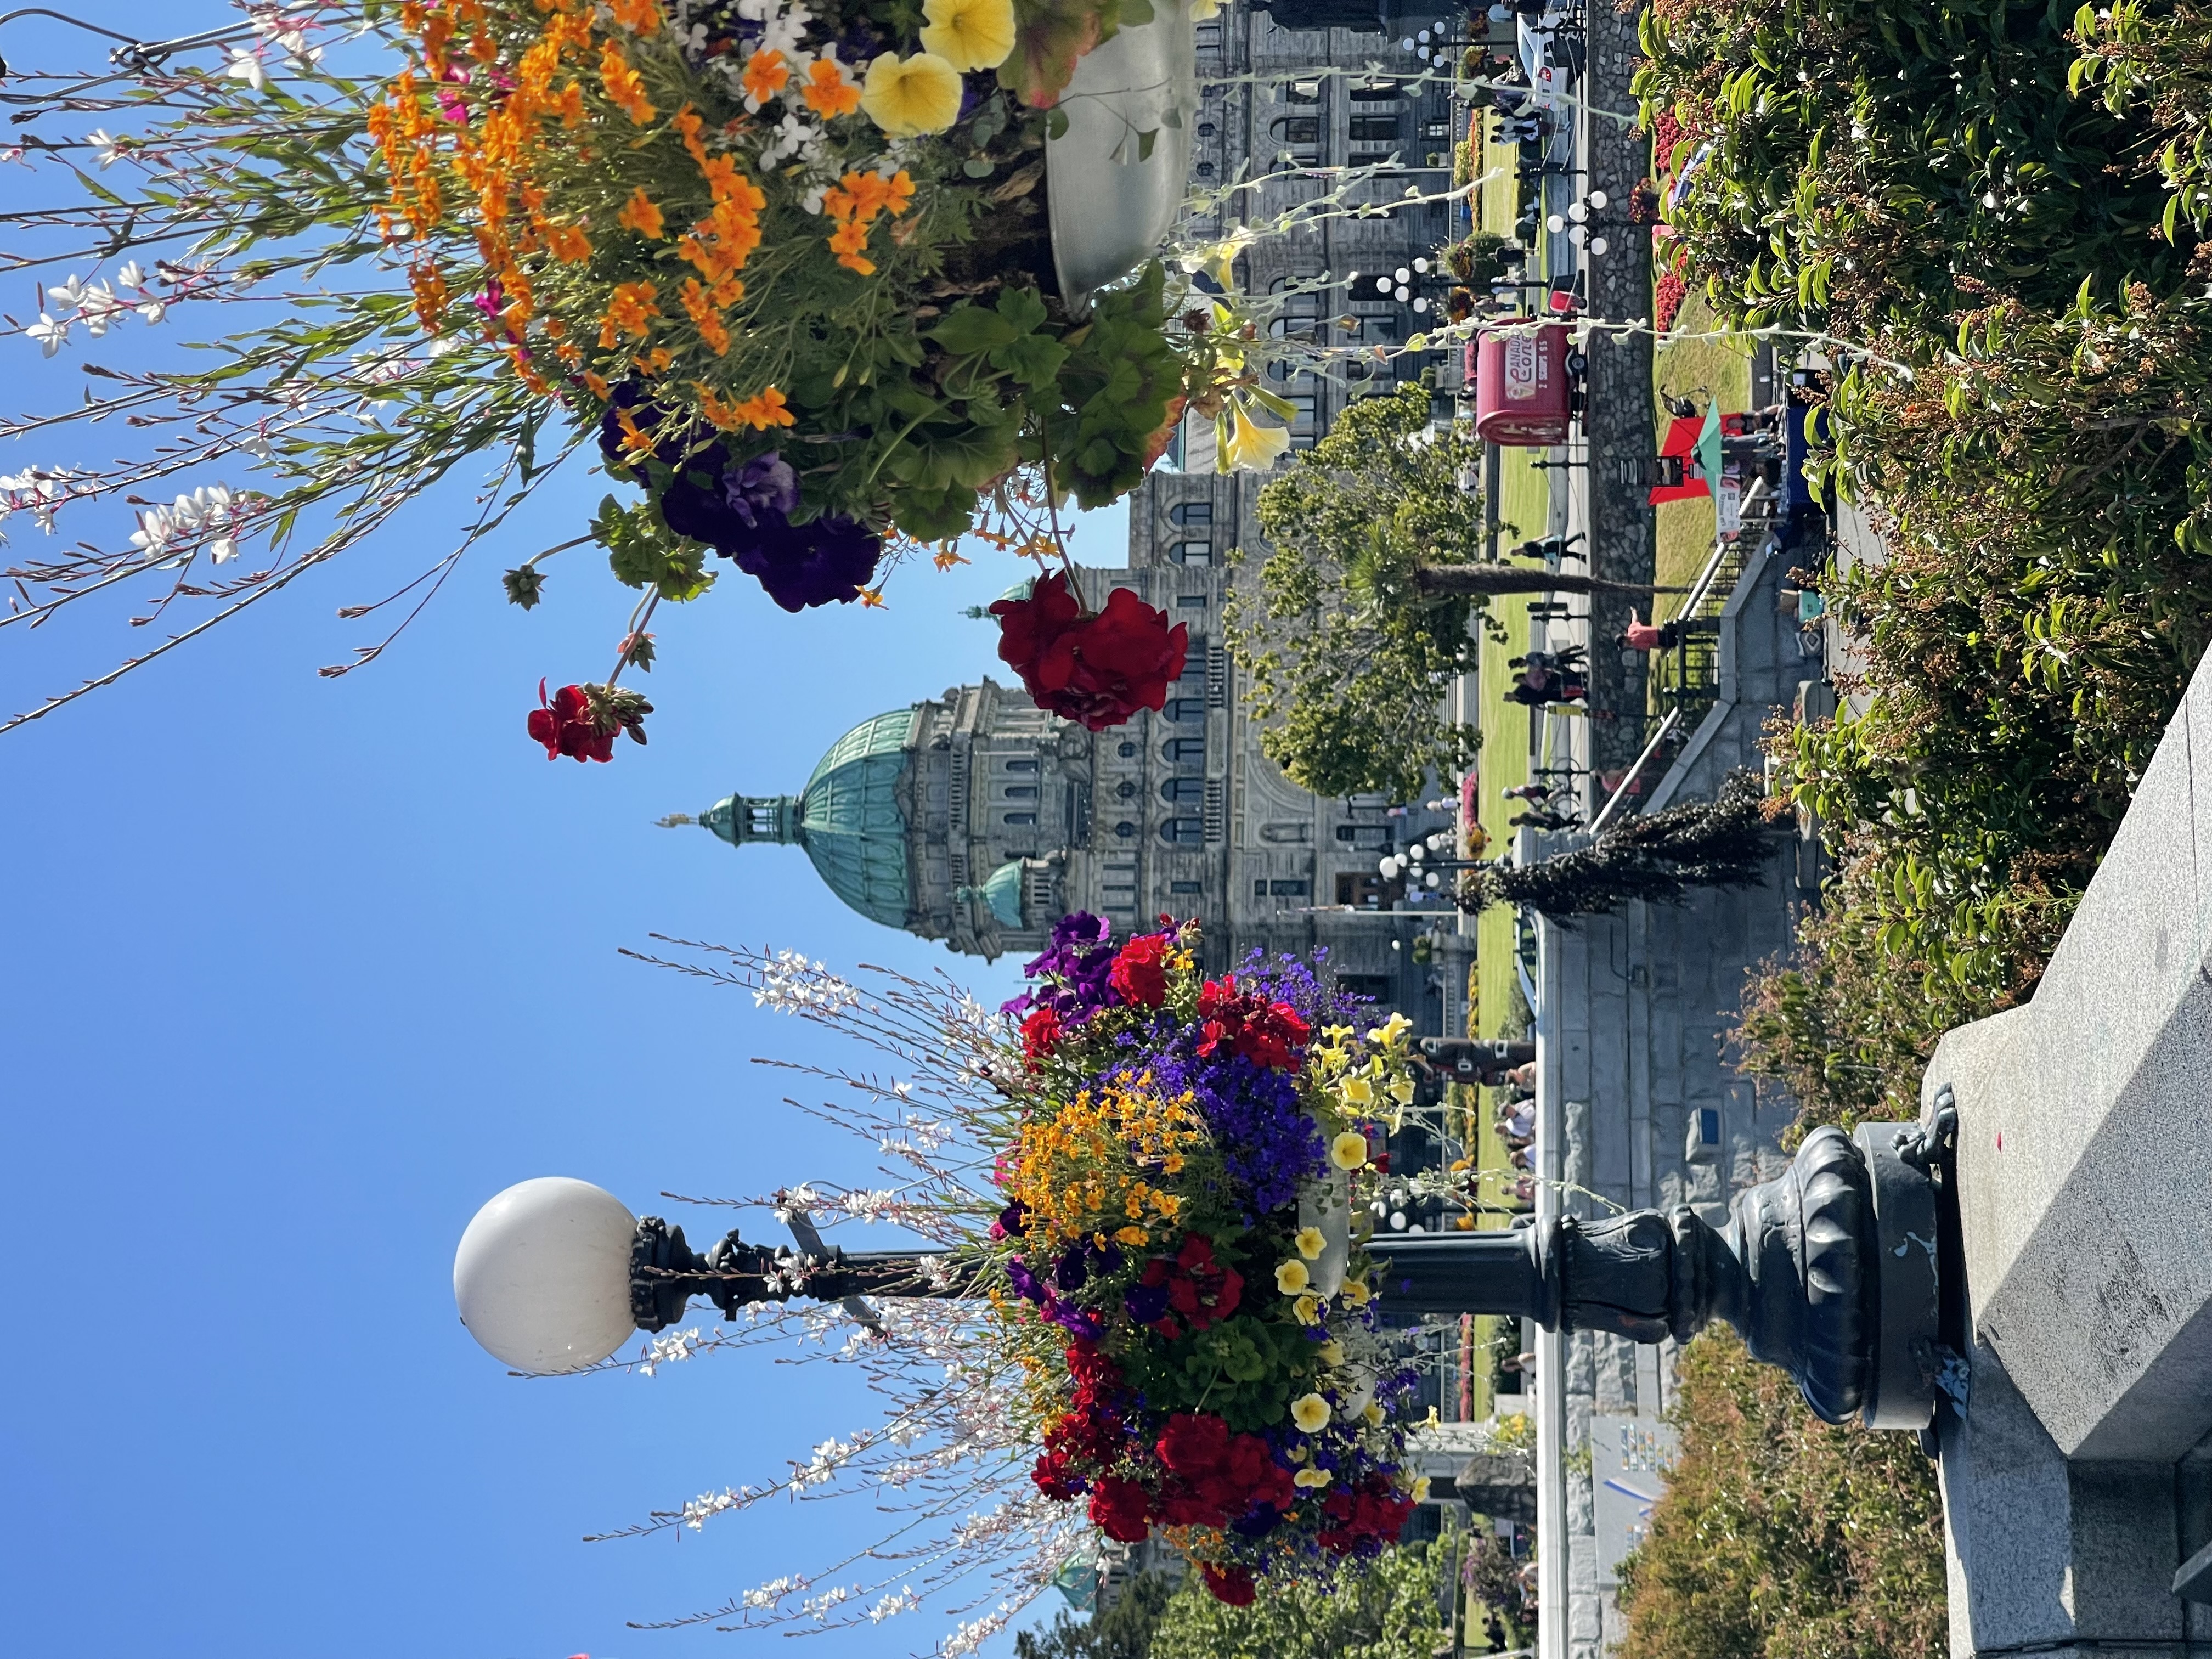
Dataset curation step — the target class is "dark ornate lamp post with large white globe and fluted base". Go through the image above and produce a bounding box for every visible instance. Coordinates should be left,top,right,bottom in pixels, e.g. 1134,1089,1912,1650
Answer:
454,1115,1951,1429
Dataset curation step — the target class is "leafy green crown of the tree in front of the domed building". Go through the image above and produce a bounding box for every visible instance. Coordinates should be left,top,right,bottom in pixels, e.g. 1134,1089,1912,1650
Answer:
1226,385,1482,801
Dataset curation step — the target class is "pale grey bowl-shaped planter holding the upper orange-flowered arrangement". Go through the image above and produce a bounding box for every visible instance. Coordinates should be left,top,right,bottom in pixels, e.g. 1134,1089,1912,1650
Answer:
1044,0,1199,312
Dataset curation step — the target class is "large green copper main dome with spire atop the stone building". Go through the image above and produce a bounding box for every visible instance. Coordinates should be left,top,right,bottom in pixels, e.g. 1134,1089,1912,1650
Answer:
699,708,913,927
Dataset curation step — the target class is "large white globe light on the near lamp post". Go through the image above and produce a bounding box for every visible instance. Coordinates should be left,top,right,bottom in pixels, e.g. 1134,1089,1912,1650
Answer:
454,1175,637,1376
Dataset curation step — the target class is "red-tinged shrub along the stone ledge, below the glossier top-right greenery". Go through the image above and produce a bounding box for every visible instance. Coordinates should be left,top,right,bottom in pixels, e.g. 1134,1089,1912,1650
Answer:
1739,292,2212,1124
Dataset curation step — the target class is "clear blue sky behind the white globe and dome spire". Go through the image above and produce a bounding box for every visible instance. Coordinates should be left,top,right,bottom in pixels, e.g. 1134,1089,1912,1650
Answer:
0,7,1126,1659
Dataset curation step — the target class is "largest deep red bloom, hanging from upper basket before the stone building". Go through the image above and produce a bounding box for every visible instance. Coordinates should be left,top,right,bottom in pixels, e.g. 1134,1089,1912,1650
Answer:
991,571,1190,732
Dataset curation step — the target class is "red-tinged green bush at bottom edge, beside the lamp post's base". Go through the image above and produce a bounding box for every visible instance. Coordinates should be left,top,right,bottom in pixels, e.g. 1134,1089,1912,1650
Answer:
1617,1327,1949,1659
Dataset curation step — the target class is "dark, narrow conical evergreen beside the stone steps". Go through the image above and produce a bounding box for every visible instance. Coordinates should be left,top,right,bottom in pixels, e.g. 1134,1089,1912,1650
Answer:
1460,772,1772,920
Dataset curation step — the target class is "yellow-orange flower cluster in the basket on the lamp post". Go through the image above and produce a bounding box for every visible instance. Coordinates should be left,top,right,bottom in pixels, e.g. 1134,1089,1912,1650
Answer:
1007,1073,1205,1248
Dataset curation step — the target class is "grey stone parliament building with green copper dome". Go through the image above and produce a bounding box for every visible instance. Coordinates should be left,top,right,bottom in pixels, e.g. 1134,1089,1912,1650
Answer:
681,7,1464,1033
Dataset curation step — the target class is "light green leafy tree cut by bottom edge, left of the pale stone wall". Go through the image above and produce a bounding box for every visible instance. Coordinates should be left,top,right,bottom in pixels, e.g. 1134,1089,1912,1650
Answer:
1150,1533,1460,1659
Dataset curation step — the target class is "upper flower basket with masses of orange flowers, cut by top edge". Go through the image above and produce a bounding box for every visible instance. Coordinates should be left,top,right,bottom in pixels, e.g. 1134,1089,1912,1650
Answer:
0,0,1272,761
